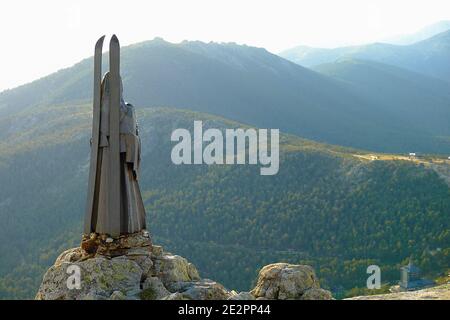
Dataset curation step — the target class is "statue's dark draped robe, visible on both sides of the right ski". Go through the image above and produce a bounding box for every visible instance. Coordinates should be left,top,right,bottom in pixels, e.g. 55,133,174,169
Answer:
86,73,146,235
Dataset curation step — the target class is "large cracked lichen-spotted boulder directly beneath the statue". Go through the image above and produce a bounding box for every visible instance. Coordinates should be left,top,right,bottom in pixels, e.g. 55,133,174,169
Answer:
36,241,216,300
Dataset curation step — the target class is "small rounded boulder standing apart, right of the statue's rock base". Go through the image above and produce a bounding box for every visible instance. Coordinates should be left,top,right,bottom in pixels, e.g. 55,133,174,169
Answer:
251,263,331,300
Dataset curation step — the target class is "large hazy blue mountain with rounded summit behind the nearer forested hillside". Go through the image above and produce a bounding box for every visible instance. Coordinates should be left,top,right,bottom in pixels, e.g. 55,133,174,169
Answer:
0,39,450,153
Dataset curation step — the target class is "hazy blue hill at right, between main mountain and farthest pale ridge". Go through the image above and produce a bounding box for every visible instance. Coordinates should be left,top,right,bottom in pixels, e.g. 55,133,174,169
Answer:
314,58,450,149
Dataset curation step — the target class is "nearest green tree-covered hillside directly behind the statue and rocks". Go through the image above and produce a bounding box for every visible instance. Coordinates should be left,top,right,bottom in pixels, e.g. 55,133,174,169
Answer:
0,105,450,298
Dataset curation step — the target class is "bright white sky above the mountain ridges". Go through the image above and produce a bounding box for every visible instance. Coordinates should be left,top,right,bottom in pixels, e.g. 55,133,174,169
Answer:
0,0,450,91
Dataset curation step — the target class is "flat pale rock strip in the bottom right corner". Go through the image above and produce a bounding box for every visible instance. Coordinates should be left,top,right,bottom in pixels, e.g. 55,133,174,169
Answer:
346,283,450,300
